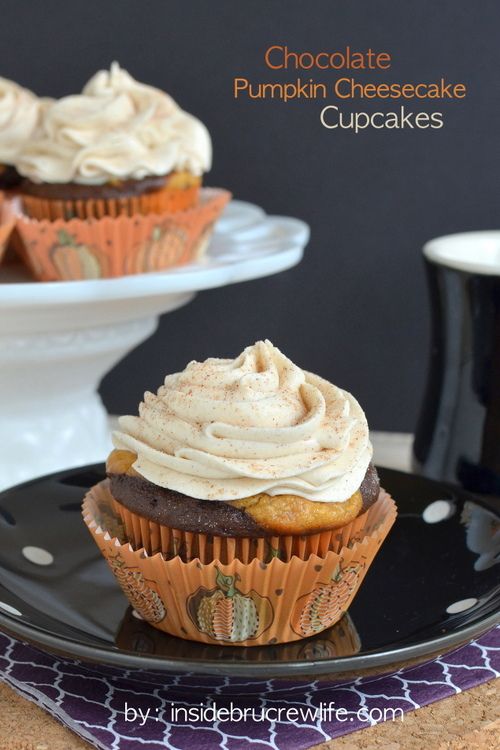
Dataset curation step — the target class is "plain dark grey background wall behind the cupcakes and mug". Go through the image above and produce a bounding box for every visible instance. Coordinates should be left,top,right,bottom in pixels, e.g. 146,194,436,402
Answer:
0,0,500,430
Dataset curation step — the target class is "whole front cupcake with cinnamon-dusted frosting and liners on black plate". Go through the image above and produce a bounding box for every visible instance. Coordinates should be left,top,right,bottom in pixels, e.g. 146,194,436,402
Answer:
84,341,395,645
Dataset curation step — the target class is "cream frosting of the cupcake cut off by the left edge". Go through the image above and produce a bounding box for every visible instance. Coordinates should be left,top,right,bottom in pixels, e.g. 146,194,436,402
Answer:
0,78,48,164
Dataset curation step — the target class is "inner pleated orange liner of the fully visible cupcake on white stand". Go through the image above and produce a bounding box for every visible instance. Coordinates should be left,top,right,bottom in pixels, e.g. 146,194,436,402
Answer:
22,185,200,221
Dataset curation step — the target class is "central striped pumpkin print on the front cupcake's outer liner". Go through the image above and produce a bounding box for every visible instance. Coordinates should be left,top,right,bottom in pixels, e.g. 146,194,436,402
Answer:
187,567,274,643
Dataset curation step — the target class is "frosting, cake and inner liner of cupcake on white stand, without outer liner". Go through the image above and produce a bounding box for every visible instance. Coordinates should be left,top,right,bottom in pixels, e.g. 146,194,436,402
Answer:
16,63,211,220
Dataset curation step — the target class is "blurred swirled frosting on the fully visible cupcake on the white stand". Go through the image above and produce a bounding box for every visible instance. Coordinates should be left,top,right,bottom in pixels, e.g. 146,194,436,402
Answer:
16,63,212,185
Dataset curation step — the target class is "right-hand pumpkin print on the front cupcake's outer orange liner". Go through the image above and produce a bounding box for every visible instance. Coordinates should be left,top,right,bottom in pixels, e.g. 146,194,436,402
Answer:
291,561,365,638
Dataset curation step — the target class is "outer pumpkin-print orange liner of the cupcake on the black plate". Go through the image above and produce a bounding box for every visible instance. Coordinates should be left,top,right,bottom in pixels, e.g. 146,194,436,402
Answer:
83,482,396,646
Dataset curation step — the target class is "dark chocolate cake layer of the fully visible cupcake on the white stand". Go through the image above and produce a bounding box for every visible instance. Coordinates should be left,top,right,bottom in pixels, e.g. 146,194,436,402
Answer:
21,175,168,201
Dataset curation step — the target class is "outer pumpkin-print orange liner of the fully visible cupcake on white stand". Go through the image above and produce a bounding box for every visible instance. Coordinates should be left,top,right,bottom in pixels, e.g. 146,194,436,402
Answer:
16,188,231,281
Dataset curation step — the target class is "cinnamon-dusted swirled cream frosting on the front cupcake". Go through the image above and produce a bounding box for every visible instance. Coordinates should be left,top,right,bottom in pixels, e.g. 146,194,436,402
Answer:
113,341,372,502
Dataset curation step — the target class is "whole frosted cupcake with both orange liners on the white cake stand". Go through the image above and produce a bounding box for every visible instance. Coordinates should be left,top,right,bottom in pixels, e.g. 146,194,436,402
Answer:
11,63,231,281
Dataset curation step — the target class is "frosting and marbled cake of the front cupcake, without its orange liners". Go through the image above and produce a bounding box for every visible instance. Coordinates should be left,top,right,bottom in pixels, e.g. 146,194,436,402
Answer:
107,341,380,554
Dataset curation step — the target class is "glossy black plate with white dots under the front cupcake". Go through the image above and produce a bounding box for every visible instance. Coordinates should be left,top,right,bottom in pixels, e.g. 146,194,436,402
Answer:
0,465,500,677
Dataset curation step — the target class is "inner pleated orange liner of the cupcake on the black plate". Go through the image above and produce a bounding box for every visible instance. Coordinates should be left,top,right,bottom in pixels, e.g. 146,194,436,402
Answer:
111,485,392,564
